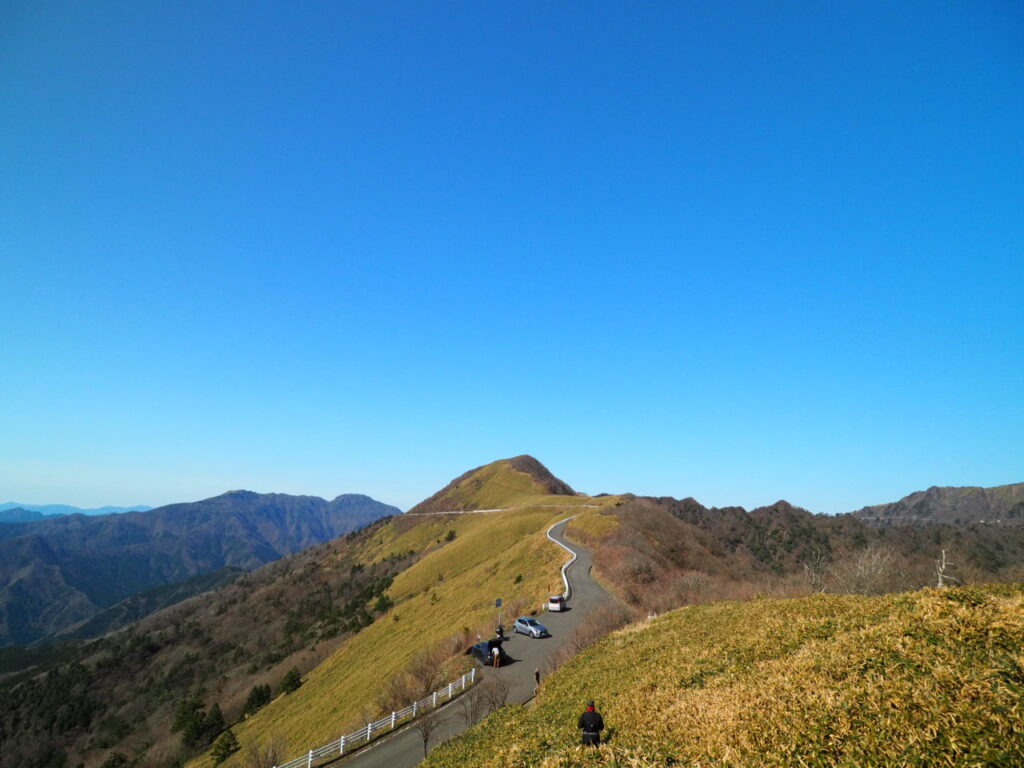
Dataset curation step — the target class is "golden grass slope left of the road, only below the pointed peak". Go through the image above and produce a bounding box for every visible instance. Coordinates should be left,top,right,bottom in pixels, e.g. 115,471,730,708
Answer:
190,497,602,766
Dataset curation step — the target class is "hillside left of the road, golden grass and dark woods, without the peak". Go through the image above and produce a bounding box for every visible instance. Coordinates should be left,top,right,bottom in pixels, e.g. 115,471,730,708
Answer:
0,460,587,768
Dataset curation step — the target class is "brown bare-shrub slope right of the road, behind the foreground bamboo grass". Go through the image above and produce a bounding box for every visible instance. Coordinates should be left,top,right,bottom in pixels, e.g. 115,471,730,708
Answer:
567,495,1024,612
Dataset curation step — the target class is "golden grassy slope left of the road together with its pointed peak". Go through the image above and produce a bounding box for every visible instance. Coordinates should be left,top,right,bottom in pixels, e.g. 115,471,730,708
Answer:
189,457,598,768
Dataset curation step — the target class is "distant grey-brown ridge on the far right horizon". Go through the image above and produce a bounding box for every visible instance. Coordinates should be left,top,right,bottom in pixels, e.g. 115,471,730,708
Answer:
853,482,1024,525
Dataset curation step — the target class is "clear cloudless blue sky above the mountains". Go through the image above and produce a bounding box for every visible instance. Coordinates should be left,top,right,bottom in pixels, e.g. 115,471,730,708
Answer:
0,0,1024,512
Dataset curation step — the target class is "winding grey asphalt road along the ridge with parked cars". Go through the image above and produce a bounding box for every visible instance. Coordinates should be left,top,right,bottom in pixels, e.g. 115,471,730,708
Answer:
333,521,611,768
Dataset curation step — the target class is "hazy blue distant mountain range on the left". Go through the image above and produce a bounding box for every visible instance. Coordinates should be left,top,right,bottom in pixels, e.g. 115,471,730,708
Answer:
0,490,398,645
